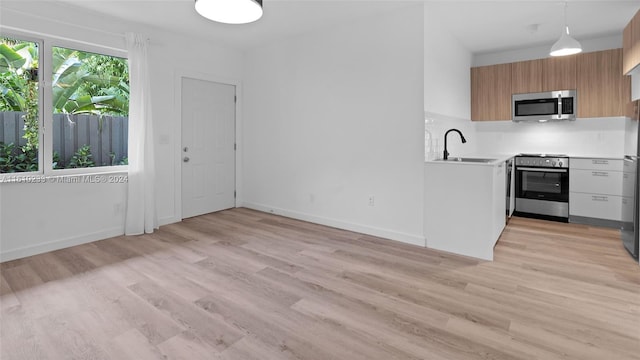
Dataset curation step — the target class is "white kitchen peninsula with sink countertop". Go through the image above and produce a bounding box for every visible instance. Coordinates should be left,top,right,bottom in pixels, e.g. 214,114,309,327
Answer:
424,156,510,260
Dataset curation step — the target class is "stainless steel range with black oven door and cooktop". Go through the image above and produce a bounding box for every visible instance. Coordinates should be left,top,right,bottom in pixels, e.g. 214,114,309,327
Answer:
515,154,569,222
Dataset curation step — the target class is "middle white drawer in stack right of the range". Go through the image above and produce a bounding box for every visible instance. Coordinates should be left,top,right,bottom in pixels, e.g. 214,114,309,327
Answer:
569,169,623,196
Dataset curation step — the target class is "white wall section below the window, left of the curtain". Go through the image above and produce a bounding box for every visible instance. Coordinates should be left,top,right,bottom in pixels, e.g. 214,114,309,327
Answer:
0,177,126,261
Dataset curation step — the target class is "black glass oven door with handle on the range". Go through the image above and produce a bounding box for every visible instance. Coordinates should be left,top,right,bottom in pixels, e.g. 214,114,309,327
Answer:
516,167,569,202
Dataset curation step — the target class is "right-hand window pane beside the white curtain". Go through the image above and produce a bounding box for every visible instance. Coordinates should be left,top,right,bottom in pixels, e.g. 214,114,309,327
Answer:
51,47,129,169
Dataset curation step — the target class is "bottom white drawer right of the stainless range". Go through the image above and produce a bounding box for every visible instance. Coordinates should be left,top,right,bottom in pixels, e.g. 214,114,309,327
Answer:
569,193,622,221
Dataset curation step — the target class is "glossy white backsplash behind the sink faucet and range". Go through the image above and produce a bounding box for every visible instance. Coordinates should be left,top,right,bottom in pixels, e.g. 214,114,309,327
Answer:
425,112,638,160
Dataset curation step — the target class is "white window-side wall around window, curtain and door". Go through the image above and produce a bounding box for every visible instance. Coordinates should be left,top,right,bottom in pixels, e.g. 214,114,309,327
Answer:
0,1,242,261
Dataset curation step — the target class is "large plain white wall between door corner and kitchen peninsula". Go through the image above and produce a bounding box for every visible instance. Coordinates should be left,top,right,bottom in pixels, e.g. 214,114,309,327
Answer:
242,4,424,245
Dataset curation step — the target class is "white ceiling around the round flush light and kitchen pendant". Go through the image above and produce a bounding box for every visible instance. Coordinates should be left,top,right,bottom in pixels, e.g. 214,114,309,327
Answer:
5,0,640,53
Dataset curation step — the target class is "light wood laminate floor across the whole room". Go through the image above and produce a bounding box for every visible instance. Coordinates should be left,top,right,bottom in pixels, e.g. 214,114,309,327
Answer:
0,209,640,360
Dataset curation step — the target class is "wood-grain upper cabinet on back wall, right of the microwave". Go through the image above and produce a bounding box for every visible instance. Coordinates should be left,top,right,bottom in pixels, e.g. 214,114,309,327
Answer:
576,49,631,117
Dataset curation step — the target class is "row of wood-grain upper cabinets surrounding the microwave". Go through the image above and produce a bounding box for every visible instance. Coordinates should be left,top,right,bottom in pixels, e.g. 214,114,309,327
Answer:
471,48,628,120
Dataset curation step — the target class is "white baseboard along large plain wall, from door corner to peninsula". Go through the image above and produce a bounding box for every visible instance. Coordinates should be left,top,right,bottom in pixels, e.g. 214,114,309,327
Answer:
238,202,425,247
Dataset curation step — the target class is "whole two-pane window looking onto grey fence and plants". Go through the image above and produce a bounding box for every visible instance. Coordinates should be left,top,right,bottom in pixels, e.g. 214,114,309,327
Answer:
0,37,129,175
